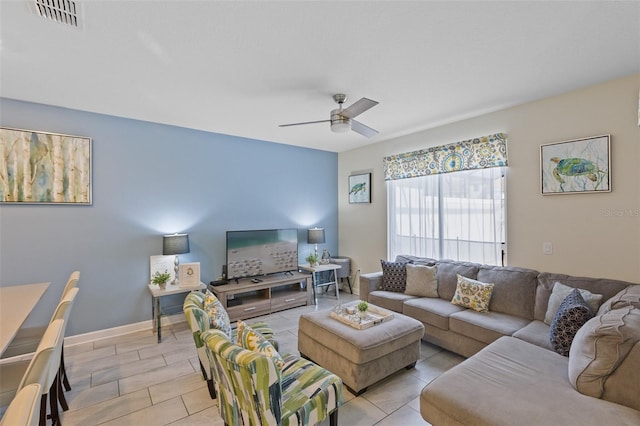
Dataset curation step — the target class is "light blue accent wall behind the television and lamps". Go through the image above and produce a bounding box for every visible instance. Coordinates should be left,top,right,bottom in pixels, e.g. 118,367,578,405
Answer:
0,98,338,335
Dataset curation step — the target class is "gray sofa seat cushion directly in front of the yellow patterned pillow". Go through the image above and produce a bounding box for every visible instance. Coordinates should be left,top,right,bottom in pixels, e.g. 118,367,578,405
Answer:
449,309,529,344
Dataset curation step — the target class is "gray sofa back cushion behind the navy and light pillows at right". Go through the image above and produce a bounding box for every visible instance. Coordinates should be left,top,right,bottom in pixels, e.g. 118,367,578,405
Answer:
534,272,631,324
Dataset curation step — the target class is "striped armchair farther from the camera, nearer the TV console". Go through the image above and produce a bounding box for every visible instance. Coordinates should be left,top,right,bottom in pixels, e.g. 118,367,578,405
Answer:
182,290,278,399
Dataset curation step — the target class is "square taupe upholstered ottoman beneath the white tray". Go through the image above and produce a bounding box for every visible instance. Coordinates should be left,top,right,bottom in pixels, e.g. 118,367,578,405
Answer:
298,304,424,395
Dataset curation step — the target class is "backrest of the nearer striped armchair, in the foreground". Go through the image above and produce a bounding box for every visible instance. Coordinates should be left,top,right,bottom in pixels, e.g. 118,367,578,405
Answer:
202,329,282,426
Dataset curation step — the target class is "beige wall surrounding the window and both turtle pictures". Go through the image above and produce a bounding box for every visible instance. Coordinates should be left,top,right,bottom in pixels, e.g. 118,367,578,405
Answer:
338,74,640,282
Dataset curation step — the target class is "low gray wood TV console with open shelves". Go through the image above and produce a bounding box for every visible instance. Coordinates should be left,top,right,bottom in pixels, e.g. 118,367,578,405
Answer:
210,272,312,321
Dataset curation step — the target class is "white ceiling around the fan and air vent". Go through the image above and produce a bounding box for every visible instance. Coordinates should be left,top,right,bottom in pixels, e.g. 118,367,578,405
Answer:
0,0,640,152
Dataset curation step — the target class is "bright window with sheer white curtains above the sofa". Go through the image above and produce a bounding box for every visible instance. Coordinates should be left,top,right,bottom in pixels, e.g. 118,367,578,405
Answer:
385,134,507,265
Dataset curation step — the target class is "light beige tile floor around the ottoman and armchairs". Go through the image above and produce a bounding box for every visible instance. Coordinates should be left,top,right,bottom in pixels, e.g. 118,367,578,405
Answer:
50,292,463,426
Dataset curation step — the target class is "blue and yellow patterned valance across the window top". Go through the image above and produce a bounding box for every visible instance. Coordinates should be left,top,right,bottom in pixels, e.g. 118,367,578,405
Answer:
384,133,508,180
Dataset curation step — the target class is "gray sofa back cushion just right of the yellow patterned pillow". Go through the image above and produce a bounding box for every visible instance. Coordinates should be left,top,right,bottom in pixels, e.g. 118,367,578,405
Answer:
476,265,539,320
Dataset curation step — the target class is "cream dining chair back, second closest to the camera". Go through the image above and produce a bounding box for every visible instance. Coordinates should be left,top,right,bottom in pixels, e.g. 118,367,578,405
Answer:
17,319,64,392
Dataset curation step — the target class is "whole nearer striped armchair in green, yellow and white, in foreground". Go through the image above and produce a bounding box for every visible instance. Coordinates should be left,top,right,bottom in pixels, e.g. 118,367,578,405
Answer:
202,329,342,426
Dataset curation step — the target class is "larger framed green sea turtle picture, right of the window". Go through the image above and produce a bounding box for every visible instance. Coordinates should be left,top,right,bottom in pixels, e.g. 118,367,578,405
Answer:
540,135,611,195
